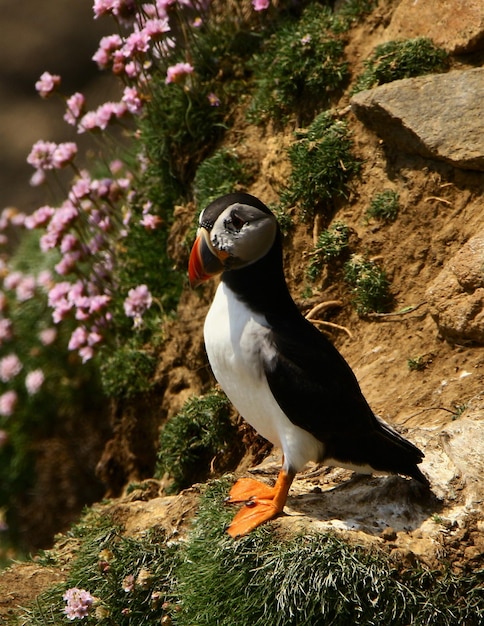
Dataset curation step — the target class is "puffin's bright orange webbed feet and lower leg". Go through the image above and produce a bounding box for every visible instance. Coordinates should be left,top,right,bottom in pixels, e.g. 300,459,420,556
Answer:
227,471,293,538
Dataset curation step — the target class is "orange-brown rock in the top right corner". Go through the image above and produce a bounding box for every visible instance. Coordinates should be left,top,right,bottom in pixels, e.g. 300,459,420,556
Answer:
385,0,484,54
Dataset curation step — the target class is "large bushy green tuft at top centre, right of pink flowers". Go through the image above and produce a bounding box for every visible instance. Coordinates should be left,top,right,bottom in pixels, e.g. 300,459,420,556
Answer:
249,3,348,123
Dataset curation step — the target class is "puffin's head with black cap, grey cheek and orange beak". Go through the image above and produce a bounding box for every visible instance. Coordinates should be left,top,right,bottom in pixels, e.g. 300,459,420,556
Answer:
188,193,278,287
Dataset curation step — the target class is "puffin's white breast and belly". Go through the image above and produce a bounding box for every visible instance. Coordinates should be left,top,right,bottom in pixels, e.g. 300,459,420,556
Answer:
204,283,323,471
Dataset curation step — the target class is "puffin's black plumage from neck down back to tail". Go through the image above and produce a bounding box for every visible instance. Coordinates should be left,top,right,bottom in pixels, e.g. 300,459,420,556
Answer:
222,210,428,485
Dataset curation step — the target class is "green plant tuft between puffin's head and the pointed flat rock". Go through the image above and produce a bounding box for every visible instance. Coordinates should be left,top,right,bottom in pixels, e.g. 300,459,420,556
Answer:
282,112,360,215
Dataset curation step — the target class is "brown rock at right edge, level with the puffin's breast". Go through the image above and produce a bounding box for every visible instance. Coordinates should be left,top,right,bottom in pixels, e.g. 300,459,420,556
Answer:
426,231,484,344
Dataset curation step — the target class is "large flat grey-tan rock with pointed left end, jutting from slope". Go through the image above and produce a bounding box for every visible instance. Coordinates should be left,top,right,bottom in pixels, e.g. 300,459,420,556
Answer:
351,68,484,171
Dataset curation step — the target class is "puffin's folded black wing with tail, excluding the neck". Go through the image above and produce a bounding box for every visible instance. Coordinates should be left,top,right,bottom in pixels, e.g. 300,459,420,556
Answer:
264,317,427,483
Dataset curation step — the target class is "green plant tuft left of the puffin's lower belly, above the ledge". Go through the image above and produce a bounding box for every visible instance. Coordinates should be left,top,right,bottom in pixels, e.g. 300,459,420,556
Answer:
155,392,239,493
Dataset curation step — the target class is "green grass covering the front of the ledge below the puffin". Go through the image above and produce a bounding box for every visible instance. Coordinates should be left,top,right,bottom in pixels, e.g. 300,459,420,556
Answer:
23,479,484,626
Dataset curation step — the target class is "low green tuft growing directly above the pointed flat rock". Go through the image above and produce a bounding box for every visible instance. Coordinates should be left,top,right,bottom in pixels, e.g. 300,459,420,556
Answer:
353,37,448,93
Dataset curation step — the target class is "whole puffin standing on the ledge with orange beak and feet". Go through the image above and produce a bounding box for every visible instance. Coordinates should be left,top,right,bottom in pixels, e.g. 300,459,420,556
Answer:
188,192,429,538
